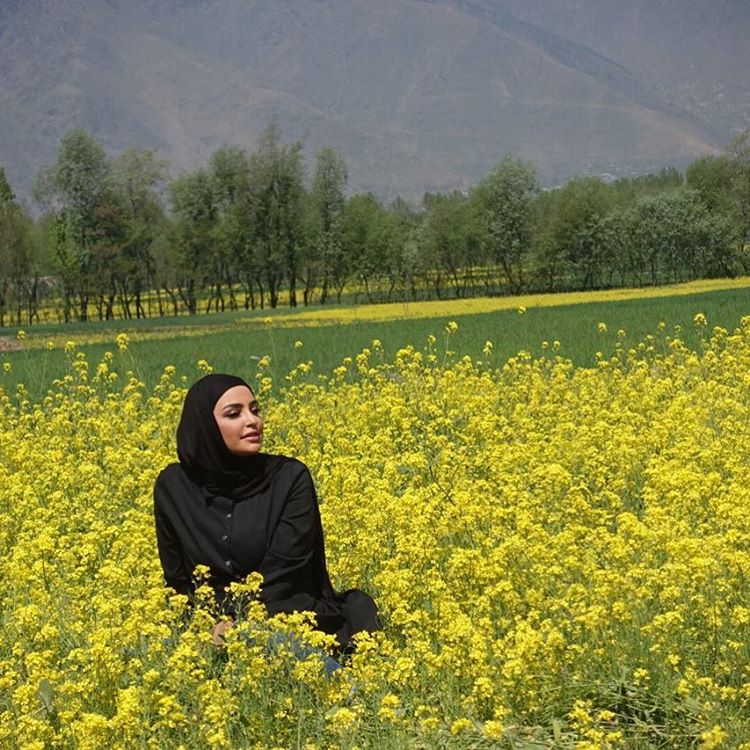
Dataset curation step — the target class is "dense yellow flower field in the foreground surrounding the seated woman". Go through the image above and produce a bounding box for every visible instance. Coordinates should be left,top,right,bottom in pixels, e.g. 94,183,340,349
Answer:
0,319,750,750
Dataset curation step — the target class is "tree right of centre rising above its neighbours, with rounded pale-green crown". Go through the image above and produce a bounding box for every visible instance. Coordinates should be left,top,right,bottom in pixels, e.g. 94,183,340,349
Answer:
472,156,538,292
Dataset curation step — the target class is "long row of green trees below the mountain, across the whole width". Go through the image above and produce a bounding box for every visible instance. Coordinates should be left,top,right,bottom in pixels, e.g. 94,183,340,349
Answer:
0,125,750,325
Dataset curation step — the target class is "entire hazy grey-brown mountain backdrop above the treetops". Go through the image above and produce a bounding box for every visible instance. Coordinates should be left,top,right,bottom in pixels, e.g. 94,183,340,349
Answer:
0,0,750,206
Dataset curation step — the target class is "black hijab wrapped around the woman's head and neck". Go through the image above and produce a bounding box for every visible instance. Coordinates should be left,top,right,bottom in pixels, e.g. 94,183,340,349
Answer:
177,373,283,500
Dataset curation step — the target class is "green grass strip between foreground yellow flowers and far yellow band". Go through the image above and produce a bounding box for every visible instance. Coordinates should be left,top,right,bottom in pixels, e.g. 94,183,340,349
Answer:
0,288,750,397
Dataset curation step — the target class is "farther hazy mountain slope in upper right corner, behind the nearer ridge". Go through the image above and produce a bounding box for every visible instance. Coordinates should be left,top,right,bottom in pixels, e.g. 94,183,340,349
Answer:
502,0,750,138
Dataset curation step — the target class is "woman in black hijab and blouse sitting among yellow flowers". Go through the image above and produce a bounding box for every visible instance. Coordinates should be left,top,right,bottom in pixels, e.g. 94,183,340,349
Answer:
154,374,379,651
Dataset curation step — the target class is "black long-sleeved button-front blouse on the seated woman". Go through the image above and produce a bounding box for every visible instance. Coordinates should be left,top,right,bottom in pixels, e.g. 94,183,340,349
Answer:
154,458,379,649
